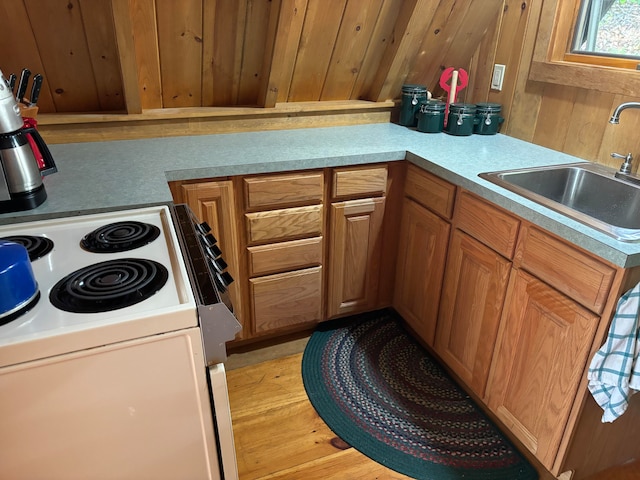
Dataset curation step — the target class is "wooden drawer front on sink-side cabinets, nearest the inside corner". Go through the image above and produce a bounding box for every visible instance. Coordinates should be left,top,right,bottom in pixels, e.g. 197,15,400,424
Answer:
404,164,456,219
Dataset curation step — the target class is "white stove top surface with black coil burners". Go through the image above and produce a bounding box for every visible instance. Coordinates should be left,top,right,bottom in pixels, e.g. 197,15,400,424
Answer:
0,206,198,366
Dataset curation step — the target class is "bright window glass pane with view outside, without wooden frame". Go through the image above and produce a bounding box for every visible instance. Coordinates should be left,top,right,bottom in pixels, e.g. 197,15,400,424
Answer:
571,0,640,60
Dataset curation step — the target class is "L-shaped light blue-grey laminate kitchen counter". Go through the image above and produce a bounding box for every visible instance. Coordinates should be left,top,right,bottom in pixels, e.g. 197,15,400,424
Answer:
0,123,640,267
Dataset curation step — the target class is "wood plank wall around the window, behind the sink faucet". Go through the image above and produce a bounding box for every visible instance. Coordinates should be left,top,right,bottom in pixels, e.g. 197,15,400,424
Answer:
488,0,640,171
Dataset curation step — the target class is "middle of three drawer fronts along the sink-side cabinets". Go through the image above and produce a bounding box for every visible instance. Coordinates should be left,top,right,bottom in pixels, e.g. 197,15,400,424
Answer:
454,192,520,258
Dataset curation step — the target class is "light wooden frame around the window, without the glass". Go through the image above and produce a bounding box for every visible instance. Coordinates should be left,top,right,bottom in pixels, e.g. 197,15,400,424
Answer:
529,0,640,97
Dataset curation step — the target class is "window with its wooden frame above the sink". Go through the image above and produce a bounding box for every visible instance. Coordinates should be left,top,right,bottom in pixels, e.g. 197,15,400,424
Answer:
529,0,640,97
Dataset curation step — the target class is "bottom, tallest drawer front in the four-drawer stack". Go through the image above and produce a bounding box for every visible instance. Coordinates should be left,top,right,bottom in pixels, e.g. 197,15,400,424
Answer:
249,267,322,333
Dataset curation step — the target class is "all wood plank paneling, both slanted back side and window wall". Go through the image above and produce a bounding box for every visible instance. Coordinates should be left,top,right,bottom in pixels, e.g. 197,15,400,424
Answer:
0,0,640,166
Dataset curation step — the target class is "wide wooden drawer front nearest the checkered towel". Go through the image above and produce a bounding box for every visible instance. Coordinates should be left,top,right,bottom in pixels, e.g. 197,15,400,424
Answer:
515,224,615,313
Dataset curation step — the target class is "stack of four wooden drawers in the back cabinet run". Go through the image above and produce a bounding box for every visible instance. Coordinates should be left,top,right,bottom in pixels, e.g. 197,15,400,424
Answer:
242,170,324,336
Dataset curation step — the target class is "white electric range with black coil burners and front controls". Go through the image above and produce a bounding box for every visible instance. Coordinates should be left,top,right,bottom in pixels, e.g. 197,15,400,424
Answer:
0,206,239,479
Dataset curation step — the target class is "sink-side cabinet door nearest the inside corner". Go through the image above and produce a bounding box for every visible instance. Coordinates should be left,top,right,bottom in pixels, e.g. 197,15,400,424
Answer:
393,198,451,346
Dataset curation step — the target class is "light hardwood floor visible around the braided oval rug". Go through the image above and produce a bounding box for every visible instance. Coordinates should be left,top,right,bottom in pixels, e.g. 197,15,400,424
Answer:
227,348,640,480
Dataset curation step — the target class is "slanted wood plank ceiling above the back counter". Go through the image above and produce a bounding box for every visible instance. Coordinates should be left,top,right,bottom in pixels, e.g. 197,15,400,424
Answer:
0,0,502,113
